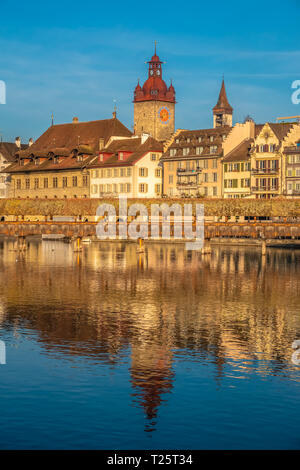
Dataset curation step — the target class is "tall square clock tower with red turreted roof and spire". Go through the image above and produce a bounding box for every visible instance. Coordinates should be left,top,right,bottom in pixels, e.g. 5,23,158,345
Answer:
133,44,175,141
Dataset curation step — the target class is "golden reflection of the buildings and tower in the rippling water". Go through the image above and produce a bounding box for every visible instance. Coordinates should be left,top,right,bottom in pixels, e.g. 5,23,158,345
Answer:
0,241,300,430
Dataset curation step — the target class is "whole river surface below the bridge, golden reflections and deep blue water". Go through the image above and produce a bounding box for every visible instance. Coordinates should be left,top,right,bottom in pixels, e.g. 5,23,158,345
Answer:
0,240,300,449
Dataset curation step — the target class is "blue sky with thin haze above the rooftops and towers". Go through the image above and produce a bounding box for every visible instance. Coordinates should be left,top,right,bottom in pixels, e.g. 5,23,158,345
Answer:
0,0,300,142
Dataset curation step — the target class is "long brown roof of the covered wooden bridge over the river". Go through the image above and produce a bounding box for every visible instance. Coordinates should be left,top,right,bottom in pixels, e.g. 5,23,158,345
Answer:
0,198,300,217
